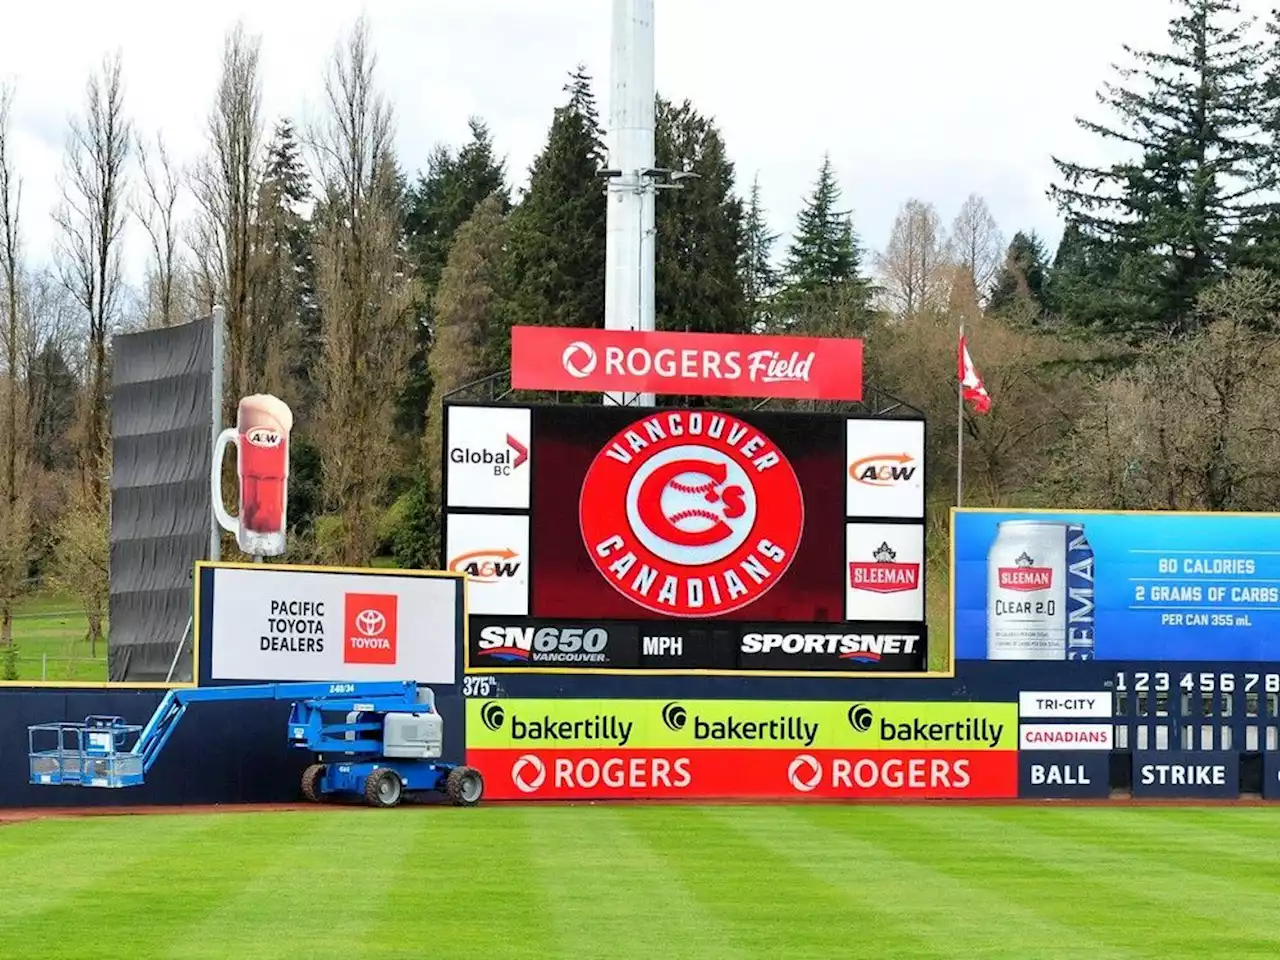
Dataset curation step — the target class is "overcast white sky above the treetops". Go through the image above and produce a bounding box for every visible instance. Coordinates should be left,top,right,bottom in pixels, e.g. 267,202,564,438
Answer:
0,0,1198,289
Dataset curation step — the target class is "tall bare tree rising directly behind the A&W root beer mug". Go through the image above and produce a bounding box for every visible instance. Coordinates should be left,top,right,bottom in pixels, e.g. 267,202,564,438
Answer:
191,23,264,404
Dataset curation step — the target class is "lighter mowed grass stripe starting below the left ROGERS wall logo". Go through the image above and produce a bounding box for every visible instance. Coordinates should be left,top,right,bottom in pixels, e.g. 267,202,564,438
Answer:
522,806,756,960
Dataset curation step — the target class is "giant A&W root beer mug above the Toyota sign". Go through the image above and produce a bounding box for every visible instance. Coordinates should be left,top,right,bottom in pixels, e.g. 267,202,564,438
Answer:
211,393,293,557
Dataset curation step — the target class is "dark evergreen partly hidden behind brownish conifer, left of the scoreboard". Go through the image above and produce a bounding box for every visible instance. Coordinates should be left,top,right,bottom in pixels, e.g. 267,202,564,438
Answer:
397,118,511,436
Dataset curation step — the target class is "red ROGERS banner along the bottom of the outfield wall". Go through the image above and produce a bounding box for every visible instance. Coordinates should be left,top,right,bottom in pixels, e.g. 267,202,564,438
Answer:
467,749,1018,800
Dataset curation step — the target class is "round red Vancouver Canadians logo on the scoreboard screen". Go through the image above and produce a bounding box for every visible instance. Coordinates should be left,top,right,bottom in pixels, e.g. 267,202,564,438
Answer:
579,411,804,617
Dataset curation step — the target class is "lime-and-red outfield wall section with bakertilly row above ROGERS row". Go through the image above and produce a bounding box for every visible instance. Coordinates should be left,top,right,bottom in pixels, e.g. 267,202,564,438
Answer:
467,699,1018,800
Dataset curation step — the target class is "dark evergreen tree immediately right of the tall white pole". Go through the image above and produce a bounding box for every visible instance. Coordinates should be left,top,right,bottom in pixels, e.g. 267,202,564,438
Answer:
654,97,748,333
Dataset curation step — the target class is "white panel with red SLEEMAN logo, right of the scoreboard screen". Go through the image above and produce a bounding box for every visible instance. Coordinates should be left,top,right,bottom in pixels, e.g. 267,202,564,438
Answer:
845,524,924,622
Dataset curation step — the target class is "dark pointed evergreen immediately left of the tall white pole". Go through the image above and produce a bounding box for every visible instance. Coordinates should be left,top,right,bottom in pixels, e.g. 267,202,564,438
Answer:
494,67,605,357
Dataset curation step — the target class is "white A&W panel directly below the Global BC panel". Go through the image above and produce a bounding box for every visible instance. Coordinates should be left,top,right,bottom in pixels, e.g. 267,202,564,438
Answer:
444,513,529,617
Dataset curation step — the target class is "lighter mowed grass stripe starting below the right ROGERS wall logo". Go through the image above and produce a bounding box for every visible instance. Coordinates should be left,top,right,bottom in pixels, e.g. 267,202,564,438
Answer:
759,806,1144,960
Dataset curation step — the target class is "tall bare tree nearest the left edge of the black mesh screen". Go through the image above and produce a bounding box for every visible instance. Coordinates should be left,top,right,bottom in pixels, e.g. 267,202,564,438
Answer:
54,54,133,502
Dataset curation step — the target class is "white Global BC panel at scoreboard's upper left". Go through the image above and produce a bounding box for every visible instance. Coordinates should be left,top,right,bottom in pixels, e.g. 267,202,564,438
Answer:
444,404,532,509
